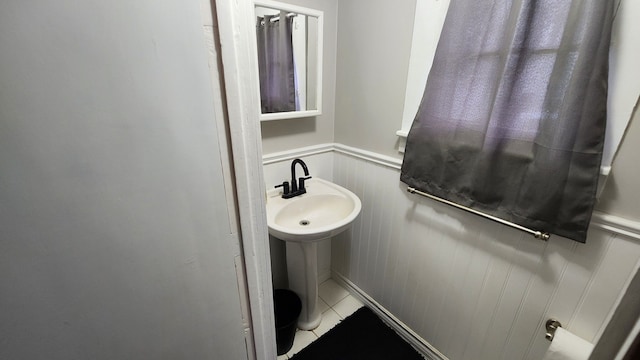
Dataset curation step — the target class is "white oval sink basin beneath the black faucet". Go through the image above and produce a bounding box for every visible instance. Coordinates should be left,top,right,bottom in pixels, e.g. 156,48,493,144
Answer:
267,178,362,242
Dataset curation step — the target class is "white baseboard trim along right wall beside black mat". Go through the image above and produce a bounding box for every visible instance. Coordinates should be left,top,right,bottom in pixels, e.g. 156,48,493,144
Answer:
331,271,449,360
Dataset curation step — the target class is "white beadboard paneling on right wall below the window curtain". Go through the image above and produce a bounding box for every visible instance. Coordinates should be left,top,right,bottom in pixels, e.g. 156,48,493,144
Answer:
331,150,640,360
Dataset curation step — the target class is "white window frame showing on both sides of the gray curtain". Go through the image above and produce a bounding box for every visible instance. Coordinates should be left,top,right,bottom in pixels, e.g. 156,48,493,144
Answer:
396,0,640,180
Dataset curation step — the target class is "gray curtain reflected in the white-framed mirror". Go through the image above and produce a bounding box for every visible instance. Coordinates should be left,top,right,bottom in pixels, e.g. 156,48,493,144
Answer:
256,11,296,114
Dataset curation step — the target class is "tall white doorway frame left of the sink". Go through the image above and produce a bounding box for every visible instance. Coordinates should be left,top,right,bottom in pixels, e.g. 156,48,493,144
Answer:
211,0,277,360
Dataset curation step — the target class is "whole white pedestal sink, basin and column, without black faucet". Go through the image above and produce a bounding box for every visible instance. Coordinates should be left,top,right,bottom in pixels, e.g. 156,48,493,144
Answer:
267,178,362,330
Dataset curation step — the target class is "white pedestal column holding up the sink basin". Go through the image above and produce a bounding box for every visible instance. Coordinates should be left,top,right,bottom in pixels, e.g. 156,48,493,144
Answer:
286,241,321,330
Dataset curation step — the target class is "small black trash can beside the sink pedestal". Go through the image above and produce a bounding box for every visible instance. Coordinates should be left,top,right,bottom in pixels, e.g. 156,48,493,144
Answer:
273,289,302,355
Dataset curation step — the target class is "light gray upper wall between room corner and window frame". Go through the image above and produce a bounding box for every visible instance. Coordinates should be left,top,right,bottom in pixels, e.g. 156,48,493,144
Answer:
335,0,418,158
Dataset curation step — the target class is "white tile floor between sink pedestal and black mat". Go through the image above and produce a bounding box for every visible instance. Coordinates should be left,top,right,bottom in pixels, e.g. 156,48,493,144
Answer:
278,279,363,360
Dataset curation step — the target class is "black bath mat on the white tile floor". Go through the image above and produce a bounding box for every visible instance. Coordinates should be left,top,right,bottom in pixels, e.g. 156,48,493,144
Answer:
291,307,424,360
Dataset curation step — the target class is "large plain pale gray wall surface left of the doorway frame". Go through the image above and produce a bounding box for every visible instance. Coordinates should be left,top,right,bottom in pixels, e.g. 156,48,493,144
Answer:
0,0,247,360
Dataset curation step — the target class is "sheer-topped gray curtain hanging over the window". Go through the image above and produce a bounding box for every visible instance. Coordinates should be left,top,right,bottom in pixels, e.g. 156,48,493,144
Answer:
401,0,613,242
